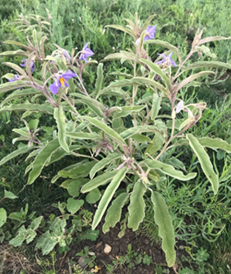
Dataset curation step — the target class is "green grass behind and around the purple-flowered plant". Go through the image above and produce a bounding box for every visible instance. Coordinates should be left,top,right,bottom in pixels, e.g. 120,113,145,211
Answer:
0,0,231,274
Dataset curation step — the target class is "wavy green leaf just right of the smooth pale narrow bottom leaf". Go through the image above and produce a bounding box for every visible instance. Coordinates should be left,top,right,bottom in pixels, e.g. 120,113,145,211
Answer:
102,193,129,233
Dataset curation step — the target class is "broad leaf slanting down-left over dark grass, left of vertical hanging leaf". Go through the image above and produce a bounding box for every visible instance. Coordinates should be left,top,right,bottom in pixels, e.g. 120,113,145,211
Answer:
27,139,59,185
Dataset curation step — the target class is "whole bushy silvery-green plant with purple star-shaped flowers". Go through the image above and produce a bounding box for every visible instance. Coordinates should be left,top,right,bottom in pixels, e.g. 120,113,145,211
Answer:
0,14,231,267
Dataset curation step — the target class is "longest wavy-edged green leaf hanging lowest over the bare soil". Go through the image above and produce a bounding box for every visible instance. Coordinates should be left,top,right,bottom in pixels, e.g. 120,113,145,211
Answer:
151,191,176,267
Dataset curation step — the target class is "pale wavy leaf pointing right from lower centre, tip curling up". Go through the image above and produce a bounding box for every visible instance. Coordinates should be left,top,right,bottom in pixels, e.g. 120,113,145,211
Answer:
143,159,197,181
